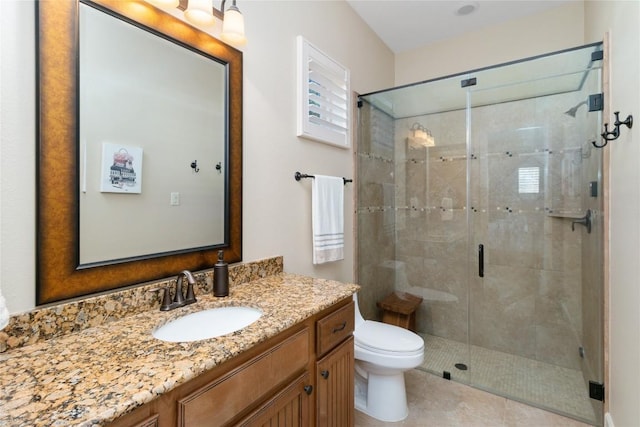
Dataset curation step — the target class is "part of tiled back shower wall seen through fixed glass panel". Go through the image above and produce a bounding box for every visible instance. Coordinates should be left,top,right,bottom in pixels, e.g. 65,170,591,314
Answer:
396,111,469,342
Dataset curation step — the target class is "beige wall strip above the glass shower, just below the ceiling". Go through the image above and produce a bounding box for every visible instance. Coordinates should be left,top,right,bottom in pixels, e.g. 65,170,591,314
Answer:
395,2,584,85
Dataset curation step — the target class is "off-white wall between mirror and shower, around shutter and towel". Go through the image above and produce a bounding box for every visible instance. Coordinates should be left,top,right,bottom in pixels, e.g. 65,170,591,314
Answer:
242,1,393,281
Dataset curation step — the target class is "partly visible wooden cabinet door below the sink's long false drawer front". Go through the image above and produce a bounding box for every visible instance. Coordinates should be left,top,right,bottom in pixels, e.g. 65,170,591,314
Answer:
238,372,313,427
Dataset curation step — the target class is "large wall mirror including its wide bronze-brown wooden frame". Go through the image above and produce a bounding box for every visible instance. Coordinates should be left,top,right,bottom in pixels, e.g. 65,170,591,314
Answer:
36,0,242,304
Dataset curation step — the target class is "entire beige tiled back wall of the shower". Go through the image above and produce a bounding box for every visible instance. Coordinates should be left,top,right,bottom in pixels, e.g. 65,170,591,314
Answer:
395,93,589,369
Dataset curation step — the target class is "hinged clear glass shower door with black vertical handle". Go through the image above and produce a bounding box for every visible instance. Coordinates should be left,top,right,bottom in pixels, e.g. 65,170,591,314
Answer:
467,46,604,424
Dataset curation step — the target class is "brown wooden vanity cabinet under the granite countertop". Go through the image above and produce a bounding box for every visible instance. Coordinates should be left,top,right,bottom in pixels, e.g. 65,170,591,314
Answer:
110,299,354,427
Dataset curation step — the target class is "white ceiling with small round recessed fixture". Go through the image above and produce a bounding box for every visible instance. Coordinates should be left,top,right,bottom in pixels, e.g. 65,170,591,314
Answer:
347,0,580,53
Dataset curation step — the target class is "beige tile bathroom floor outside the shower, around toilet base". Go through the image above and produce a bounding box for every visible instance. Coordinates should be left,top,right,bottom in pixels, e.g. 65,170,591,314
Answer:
355,369,588,427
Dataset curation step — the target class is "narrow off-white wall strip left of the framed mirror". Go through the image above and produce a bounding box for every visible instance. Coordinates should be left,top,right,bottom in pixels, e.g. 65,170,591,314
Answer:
0,1,36,312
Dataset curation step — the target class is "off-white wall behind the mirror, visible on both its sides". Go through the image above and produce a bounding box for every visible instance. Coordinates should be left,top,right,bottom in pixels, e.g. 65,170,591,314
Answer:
0,0,394,313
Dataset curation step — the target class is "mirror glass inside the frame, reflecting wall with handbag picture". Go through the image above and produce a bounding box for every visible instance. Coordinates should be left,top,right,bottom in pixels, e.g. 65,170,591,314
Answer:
79,4,227,265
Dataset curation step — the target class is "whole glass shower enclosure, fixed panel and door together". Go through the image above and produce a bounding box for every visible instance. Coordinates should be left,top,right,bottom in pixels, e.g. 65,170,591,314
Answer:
356,44,604,425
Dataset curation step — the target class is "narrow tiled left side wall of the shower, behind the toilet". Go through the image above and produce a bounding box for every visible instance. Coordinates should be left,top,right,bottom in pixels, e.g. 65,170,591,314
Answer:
356,103,396,319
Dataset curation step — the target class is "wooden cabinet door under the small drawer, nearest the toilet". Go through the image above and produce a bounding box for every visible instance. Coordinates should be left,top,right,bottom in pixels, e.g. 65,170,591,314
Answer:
316,336,354,427
